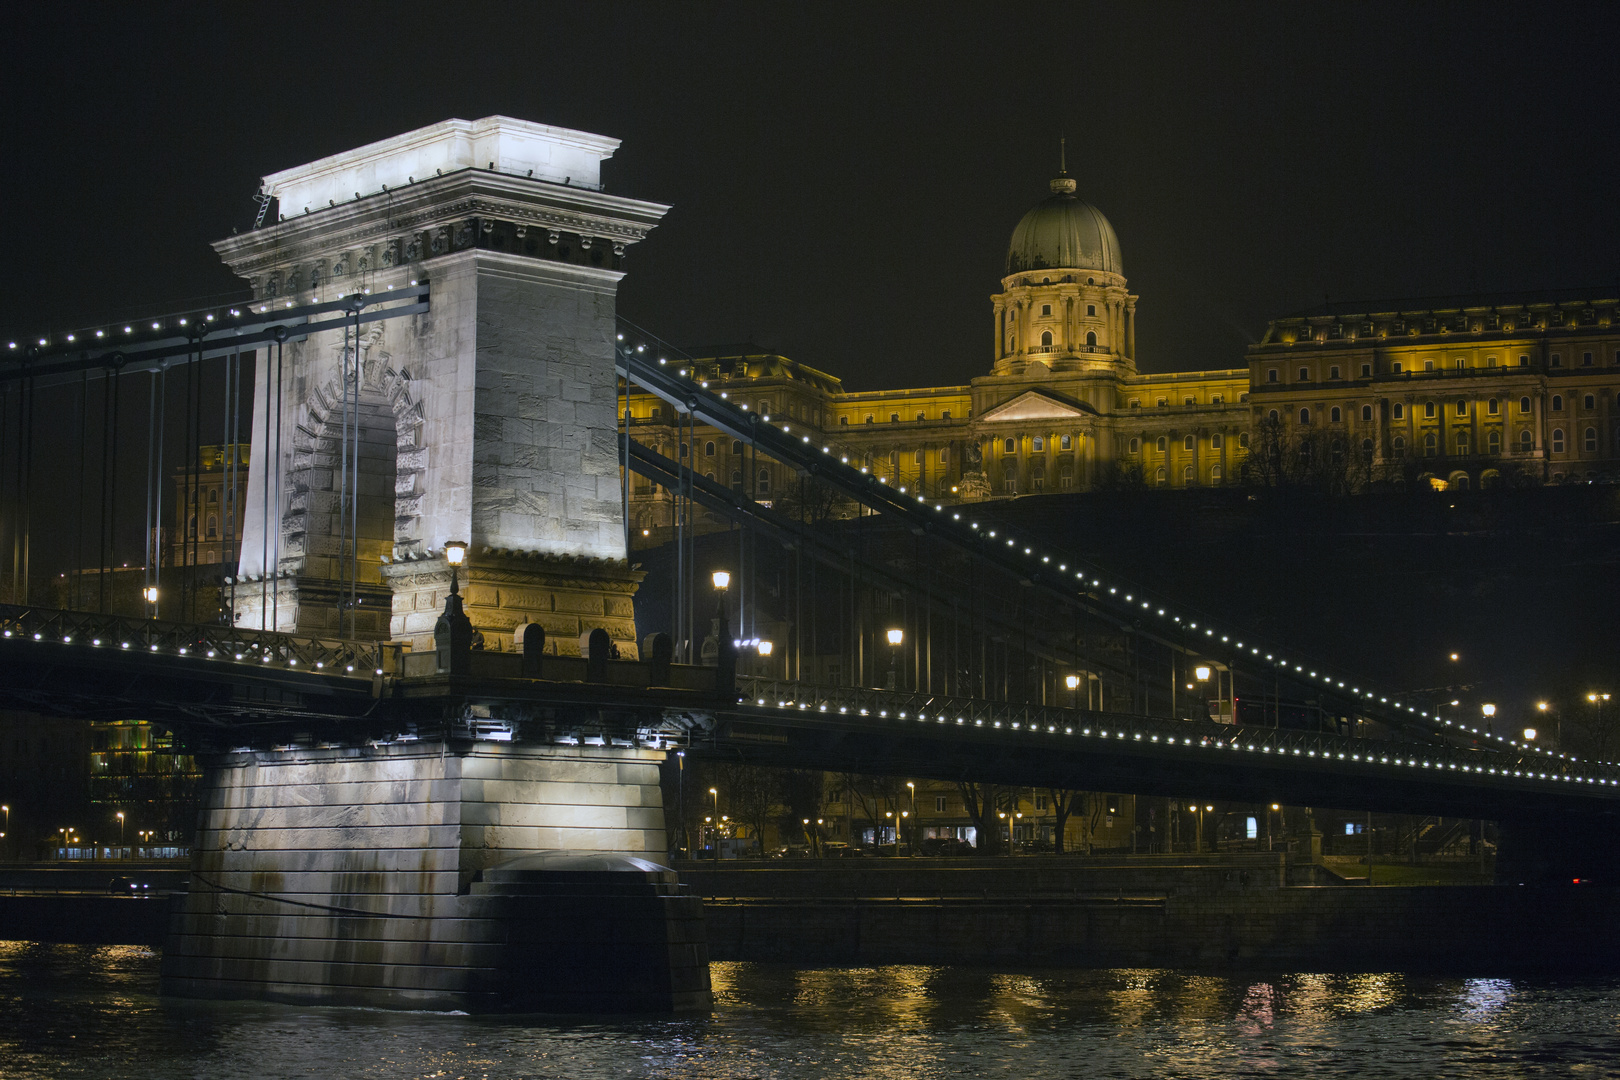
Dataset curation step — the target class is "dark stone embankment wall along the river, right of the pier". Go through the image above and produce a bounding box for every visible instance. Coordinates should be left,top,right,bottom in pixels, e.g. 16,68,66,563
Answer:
680,857,1620,973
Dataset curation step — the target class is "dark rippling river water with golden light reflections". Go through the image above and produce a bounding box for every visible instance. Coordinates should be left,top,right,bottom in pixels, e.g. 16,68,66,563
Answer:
0,942,1620,1080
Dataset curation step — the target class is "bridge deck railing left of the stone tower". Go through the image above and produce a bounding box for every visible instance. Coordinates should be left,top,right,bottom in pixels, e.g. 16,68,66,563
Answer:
0,604,382,678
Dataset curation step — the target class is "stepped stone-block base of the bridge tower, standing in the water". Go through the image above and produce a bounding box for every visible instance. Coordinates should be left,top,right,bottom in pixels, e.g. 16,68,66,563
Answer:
164,740,710,1012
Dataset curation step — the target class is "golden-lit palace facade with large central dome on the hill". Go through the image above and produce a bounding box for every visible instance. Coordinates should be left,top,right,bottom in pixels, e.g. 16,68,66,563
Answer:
630,176,1620,536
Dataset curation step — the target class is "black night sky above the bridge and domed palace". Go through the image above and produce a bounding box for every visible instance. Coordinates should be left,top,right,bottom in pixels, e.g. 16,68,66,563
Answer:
0,3,1620,389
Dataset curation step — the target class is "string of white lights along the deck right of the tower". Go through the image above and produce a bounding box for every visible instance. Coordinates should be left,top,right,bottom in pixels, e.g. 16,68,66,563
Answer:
741,698,1620,787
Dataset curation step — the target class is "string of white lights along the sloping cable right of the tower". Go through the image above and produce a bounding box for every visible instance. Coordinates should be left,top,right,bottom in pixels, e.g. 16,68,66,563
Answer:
619,334,1615,764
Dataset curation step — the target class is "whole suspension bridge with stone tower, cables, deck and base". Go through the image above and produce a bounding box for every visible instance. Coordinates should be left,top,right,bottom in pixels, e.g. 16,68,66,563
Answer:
0,118,1620,1007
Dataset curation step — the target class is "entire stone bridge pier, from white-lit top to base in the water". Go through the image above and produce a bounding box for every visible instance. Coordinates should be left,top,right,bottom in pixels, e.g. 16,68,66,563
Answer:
164,117,708,1010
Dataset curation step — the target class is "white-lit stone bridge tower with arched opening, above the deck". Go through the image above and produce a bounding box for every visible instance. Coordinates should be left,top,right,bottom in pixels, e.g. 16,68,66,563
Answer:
215,117,667,657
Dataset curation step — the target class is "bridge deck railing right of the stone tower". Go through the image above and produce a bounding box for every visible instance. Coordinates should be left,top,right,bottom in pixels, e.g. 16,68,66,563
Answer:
737,677,1620,789
